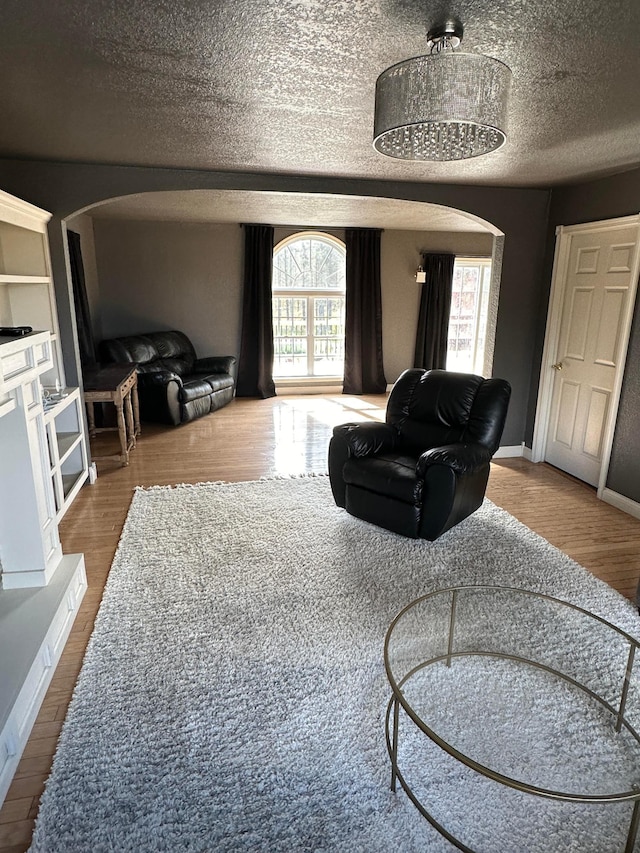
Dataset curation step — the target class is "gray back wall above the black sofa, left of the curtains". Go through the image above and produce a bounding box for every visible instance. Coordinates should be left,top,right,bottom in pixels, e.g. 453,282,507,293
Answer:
94,219,242,357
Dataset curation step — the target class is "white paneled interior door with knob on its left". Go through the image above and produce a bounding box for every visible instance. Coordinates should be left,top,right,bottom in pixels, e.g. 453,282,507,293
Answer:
543,222,638,486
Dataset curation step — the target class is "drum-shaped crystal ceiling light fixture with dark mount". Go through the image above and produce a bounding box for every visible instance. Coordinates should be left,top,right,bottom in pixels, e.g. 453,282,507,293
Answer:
373,20,511,160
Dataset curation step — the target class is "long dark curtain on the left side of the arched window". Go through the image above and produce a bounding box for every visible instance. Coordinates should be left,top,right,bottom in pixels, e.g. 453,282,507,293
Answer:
236,225,276,398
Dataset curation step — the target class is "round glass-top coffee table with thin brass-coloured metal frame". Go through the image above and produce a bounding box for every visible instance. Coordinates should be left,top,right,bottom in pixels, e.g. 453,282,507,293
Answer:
384,586,640,853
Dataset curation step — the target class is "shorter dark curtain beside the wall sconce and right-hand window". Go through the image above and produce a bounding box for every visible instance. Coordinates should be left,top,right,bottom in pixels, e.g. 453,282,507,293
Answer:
413,254,456,370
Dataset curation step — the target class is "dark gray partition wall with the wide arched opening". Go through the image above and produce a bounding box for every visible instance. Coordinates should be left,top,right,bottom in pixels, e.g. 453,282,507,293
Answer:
0,160,550,445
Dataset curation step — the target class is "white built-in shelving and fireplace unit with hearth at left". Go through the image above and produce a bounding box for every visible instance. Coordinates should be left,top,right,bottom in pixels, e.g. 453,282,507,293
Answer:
0,192,87,803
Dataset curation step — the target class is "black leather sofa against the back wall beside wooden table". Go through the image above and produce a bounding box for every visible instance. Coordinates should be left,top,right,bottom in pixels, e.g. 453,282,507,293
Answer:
99,331,236,426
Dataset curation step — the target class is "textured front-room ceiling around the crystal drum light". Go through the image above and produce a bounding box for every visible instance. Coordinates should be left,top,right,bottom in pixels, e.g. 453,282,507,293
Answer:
0,0,640,186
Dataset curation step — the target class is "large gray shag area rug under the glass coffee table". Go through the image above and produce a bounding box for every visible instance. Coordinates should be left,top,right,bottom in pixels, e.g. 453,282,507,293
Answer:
31,476,640,853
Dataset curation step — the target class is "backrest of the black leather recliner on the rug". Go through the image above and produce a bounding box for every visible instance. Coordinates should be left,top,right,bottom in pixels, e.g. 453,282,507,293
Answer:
386,368,511,453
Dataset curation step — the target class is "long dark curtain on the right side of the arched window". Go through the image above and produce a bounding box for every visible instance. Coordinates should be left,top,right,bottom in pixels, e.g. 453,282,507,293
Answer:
343,228,387,394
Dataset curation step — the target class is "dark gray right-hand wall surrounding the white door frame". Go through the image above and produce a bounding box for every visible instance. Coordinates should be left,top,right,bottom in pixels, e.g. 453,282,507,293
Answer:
528,164,640,502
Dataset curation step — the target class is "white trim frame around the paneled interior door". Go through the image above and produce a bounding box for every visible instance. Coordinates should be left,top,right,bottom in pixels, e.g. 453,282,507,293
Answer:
531,214,640,498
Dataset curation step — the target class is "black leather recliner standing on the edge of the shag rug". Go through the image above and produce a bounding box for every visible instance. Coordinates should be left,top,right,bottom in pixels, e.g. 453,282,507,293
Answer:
329,369,511,541
